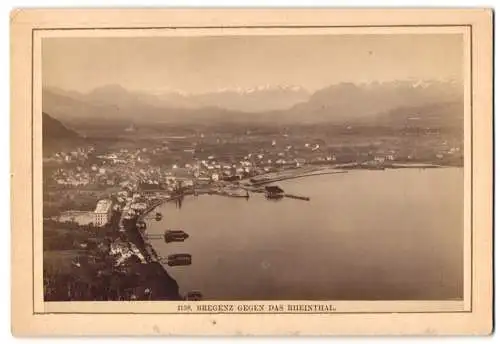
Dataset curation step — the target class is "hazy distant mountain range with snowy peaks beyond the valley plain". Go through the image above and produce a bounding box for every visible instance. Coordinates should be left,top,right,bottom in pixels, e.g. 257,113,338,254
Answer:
42,80,463,127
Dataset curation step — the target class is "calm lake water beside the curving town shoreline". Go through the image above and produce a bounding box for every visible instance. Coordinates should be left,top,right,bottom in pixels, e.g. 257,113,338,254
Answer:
147,168,464,300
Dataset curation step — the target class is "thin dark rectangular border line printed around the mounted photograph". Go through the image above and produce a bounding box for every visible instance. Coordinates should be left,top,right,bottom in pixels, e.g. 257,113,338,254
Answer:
34,24,472,315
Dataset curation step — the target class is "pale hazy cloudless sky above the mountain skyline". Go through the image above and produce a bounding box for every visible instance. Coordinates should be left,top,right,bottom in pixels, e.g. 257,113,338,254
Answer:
42,34,463,93
